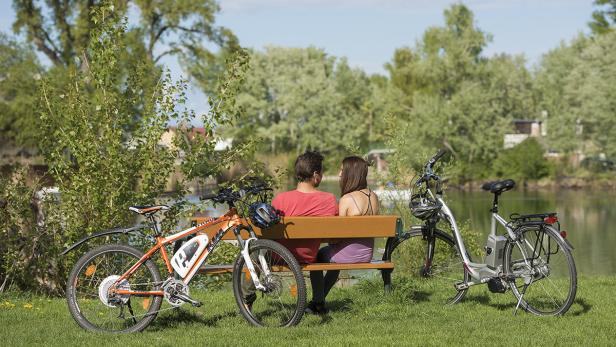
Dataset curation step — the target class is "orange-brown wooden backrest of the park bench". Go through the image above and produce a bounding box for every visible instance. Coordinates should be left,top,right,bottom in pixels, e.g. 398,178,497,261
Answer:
192,215,402,240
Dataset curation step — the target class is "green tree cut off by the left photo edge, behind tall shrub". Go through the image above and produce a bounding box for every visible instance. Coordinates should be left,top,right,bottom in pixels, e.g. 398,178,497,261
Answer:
0,34,43,148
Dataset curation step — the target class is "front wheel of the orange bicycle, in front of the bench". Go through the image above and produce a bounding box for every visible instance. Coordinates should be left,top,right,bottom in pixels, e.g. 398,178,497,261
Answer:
233,240,306,327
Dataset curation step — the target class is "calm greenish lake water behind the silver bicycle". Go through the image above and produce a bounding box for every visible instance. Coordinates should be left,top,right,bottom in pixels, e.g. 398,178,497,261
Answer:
320,182,616,275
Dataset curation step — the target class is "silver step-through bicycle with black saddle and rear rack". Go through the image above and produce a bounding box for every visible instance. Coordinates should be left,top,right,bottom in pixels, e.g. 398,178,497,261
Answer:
384,150,577,315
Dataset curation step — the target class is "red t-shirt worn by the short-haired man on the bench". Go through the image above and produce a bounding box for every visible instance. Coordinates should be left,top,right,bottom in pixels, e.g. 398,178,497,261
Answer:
272,190,338,263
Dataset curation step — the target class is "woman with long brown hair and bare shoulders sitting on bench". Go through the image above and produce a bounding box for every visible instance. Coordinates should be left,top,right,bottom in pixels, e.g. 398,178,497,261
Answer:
307,156,379,314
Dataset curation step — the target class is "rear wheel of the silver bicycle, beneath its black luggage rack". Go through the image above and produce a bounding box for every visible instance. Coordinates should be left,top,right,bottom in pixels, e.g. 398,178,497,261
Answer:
504,225,577,316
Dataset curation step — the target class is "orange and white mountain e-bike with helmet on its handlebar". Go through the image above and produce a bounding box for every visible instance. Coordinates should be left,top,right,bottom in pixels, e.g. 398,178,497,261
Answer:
63,185,306,333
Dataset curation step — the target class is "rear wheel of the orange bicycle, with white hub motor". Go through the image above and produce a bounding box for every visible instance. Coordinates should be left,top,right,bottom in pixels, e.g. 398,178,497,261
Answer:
66,245,162,333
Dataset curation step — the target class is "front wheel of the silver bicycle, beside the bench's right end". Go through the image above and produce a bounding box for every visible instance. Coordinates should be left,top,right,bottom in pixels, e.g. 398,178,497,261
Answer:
390,229,470,305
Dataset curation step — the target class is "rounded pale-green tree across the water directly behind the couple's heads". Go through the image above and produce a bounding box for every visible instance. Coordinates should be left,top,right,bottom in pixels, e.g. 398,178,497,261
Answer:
217,47,382,168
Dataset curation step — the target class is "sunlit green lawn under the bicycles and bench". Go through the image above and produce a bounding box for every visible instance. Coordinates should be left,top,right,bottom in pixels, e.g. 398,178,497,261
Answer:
0,277,616,346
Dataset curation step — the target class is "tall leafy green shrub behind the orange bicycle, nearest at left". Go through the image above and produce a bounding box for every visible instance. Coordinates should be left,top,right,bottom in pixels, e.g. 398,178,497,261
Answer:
0,1,252,293
